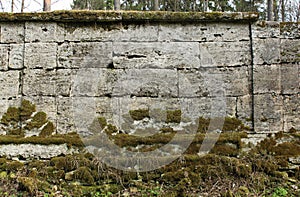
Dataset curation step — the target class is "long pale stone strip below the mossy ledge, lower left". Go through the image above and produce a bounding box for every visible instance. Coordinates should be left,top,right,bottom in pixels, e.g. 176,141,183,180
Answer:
0,144,77,159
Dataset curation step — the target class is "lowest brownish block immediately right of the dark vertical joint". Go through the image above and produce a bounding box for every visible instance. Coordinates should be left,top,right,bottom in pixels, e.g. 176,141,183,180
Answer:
254,94,284,133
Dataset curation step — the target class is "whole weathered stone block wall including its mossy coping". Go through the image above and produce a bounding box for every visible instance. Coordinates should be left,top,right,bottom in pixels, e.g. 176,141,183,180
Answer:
0,12,300,137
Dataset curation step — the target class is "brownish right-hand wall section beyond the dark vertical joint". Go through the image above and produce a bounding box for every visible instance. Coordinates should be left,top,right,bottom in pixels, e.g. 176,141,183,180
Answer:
252,21,300,132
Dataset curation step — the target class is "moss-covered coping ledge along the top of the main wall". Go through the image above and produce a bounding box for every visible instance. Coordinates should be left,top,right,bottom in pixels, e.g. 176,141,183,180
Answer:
0,10,259,23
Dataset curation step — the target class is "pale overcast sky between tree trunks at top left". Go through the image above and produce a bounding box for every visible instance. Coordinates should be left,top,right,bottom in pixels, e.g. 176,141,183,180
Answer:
0,0,73,12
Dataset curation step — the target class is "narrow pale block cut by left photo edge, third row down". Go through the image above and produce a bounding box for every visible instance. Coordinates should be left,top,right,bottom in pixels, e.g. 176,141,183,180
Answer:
0,71,20,98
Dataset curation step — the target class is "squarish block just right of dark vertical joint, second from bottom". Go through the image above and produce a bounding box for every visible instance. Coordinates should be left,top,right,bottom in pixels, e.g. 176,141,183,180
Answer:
253,65,281,94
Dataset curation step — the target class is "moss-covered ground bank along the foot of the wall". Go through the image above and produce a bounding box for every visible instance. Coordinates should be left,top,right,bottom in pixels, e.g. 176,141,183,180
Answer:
0,127,300,197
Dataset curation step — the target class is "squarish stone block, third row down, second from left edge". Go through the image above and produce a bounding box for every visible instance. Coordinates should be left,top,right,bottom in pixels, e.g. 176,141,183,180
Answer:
23,69,56,96
